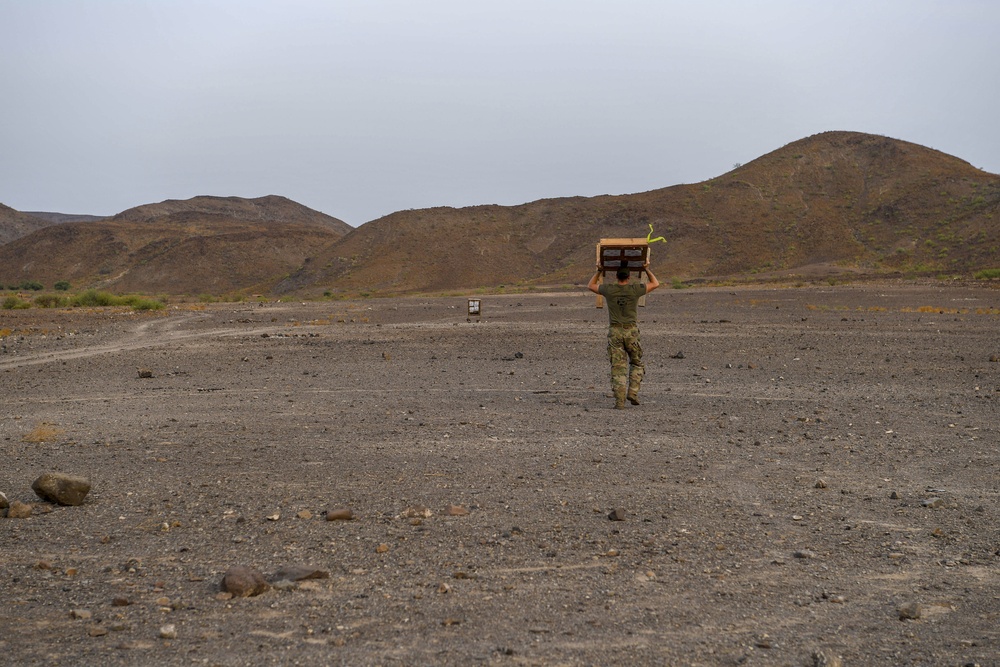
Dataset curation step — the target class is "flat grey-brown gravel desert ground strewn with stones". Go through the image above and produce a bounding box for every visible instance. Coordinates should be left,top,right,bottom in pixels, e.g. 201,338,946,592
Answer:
0,283,1000,666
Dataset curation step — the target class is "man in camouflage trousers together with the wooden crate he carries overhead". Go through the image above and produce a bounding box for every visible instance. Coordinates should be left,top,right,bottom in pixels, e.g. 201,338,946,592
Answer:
587,239,660,410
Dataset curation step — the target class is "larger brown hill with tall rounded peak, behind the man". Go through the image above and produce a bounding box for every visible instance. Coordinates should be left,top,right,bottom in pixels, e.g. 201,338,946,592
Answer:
278,132,1000,293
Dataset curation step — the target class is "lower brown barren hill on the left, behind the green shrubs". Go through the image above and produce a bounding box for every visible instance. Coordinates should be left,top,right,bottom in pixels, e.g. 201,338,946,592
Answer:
0,196,351,294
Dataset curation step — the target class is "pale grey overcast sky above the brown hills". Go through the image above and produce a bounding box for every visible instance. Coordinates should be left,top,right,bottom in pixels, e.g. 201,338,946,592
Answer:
0,0,1000,226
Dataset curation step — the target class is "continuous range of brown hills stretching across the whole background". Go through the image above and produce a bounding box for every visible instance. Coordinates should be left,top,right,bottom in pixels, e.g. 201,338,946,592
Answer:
0,132,1000,296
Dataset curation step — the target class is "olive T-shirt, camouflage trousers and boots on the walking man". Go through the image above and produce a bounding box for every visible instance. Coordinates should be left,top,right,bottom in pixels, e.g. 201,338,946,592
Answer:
599,284,646,408
